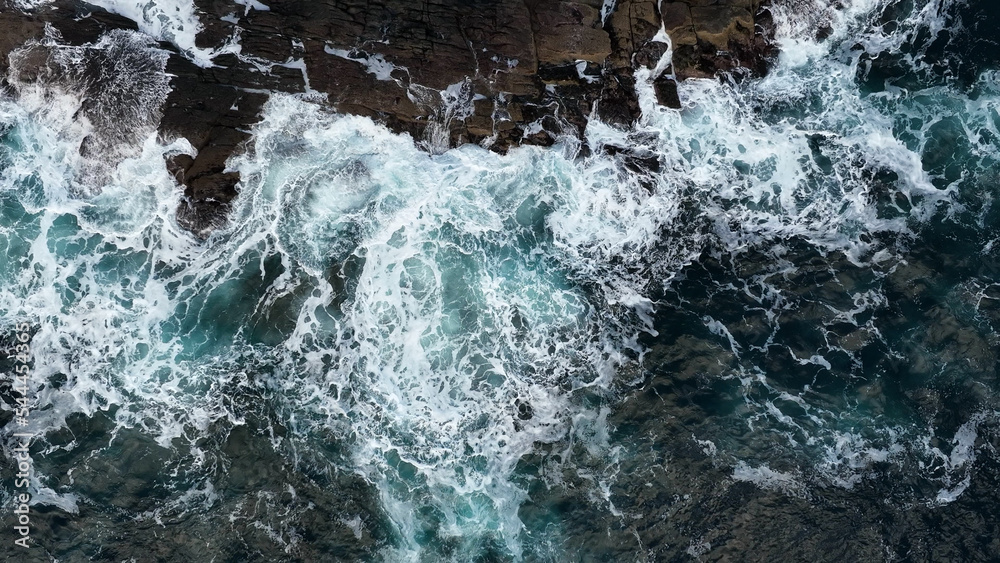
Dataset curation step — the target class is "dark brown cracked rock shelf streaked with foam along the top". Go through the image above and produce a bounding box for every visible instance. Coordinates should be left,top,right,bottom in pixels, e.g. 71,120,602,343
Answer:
0,0,773,236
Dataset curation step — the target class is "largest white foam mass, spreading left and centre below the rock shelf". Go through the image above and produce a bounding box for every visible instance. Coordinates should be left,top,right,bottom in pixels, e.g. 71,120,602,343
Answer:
0,88,670,553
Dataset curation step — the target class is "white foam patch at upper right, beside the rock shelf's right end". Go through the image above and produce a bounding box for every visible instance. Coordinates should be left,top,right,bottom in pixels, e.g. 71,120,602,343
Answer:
637,0,975,274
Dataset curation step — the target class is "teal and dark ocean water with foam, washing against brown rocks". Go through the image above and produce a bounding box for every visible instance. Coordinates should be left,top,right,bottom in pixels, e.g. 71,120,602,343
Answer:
0,0,1000,561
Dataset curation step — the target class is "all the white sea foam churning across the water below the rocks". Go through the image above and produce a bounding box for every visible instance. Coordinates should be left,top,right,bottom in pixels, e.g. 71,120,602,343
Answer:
0,2,996,559
